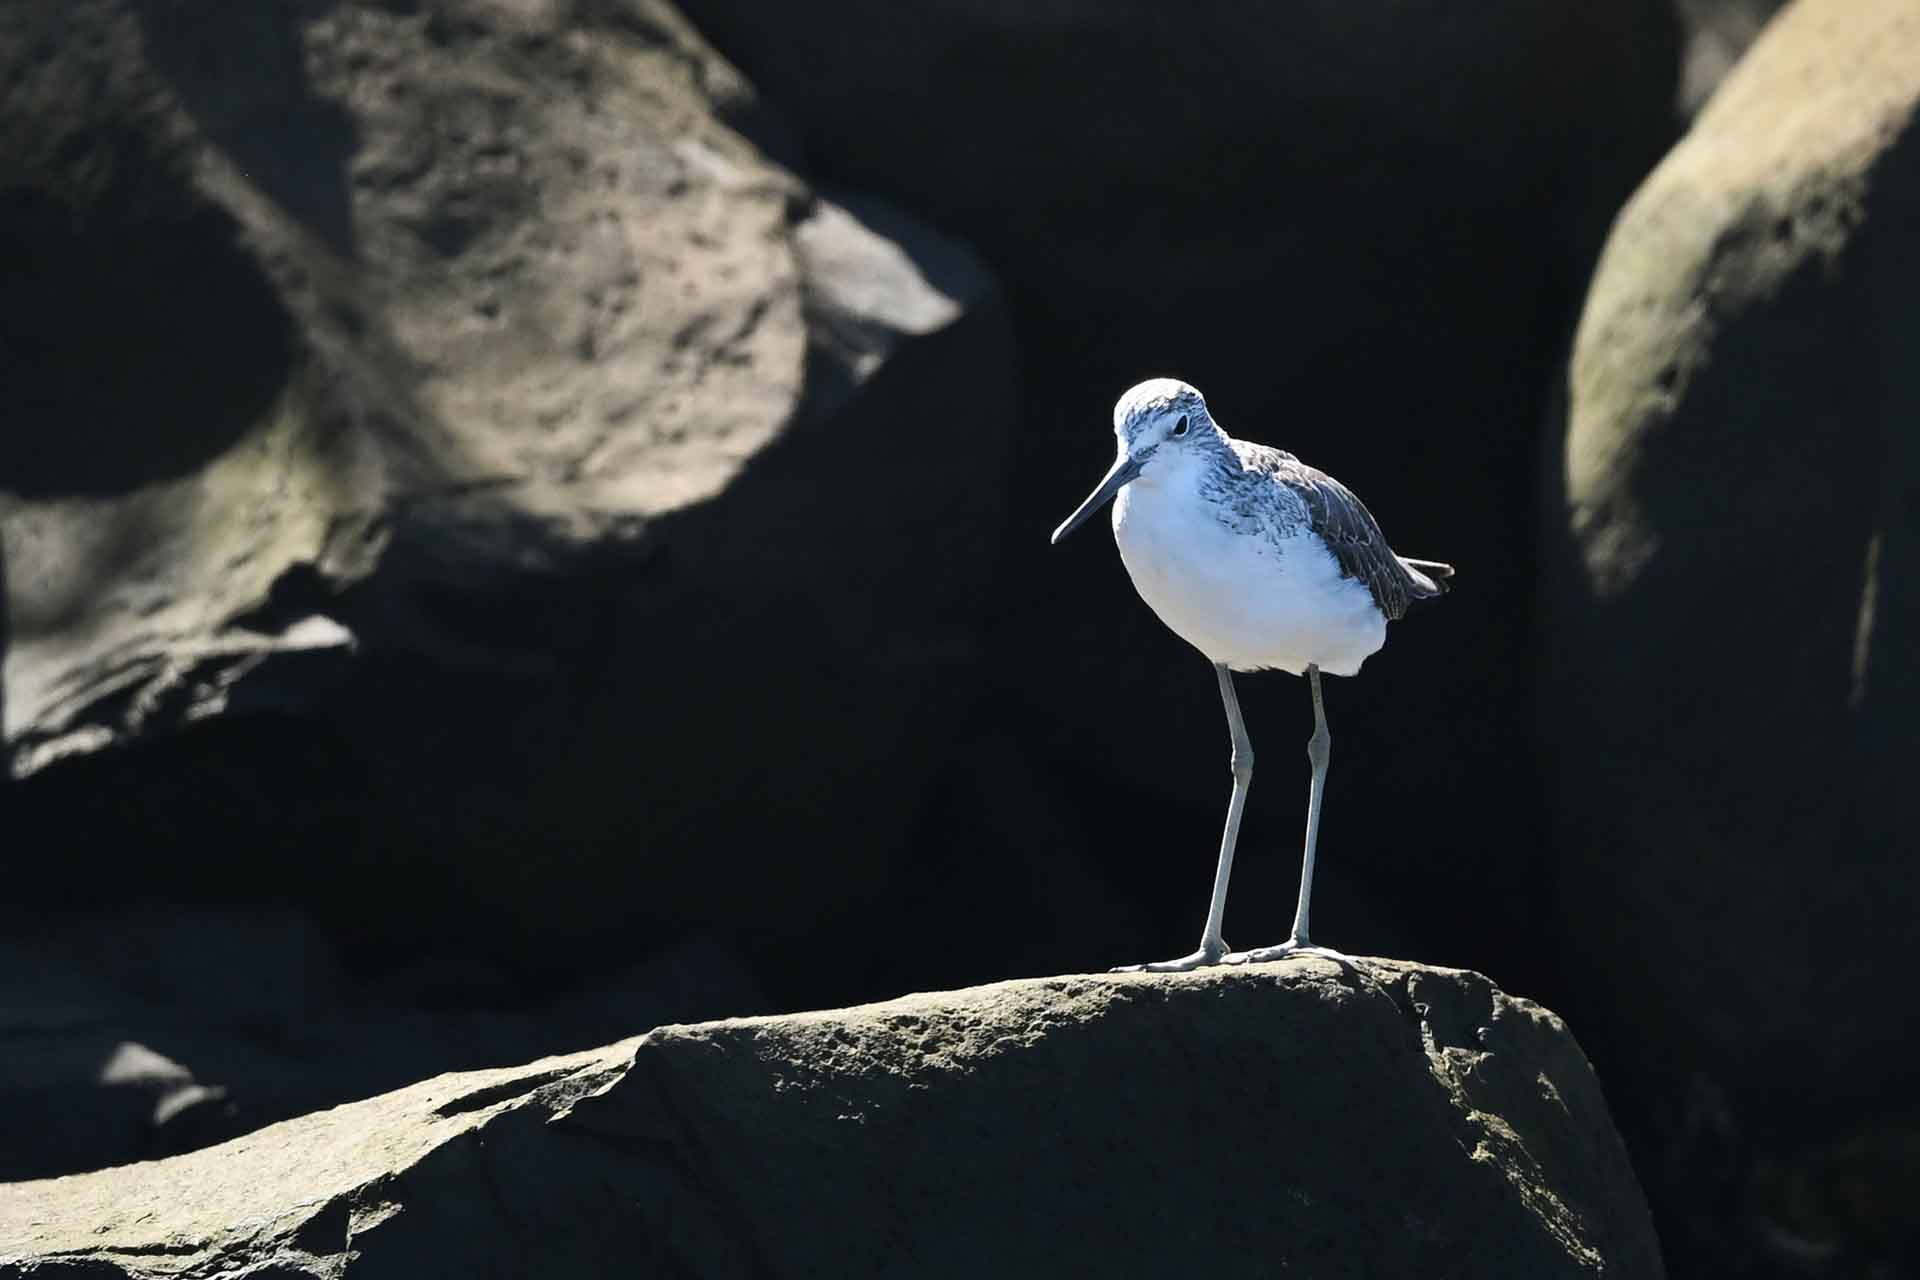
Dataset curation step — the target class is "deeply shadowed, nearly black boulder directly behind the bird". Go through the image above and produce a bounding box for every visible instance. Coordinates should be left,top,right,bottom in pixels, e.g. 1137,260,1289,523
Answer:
685,0,1678,990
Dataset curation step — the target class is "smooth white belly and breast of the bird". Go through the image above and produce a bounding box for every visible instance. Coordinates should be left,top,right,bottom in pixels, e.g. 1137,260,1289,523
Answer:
1114,484,1386,676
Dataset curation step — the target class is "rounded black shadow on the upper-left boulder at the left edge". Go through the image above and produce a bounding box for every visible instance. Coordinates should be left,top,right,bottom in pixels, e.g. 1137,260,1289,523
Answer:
0,184,292,499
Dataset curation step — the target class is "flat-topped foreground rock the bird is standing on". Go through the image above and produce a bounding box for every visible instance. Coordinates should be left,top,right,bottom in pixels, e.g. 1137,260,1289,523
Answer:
0,960,1661,1280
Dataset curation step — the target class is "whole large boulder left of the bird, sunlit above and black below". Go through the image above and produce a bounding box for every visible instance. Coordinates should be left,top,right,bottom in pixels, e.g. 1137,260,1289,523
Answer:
0,0,1012,969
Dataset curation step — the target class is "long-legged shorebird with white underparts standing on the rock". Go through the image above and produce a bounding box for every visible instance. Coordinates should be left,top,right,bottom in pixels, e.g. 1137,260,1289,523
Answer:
1052,378,1453,973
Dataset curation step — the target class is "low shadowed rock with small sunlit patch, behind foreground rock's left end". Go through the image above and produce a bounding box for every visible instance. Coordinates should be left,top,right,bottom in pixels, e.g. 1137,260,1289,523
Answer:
0,890,766,1182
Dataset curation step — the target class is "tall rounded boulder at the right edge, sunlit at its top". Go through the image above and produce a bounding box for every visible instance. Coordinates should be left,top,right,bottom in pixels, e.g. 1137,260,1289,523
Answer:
1544,0,1920,1274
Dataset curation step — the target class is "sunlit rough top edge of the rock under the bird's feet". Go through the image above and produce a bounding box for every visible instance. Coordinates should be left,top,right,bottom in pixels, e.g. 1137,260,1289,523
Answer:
0,960,1657,1280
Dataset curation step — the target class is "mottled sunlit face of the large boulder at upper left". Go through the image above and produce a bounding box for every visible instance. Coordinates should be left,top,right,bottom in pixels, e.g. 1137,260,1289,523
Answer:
0,4,979,759
